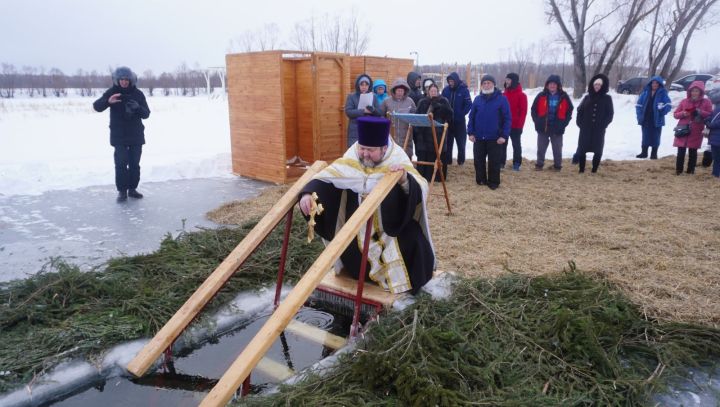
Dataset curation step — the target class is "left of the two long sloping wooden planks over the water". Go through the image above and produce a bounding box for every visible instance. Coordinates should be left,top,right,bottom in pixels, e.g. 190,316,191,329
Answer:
127,161,327,377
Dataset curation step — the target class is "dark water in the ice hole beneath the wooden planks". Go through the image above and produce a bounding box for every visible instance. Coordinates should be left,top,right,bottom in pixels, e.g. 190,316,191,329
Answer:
41,304,360,407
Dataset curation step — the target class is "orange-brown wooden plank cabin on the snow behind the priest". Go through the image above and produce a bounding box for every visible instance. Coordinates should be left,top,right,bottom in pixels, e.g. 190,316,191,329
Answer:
226,50,413,184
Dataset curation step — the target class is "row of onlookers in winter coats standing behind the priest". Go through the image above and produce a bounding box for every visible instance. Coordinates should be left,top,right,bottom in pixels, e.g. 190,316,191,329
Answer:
345,72,720,189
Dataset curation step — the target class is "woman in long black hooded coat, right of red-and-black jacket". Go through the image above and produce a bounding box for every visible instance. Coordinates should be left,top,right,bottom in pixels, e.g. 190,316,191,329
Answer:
576,74,614,173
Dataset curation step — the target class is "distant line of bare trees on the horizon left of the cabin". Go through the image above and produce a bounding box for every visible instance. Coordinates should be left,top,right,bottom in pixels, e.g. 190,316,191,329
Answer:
0,63,225,98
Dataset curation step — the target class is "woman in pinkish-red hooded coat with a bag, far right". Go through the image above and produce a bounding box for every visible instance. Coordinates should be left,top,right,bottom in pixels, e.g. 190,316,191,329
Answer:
673,81,712,175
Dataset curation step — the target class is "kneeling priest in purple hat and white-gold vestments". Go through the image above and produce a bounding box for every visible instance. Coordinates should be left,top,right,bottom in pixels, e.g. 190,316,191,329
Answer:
299,116,435,294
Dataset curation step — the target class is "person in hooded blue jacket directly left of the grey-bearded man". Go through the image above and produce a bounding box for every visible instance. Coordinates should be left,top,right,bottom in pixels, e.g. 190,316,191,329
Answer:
442,72,472,165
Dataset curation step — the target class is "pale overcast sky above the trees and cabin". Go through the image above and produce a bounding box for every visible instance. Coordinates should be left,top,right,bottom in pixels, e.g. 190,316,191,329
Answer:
0,0,720,73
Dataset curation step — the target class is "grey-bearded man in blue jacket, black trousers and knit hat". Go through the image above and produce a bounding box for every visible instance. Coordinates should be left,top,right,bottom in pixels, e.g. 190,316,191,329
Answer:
467,75,512,189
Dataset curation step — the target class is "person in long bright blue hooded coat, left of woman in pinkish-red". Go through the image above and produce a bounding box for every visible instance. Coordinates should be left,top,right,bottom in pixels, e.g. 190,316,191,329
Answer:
635,76,672,160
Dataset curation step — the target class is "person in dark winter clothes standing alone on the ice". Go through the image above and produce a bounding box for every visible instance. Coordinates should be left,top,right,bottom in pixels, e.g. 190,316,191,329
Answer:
93,66,150,202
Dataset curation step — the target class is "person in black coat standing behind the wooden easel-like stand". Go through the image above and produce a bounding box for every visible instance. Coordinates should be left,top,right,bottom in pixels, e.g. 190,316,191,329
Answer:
413,83,453,182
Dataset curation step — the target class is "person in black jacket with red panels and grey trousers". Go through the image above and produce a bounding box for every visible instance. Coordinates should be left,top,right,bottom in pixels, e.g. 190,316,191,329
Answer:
530,75,574,171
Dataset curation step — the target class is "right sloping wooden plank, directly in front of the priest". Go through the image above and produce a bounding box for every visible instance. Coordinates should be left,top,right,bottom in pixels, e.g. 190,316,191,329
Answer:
200,172,401,407
